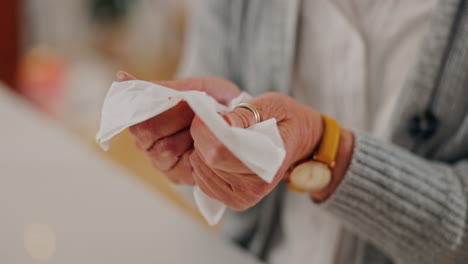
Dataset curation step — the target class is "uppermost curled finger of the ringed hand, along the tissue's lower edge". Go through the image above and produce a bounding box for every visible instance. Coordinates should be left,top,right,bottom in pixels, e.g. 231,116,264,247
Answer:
190,116,252,173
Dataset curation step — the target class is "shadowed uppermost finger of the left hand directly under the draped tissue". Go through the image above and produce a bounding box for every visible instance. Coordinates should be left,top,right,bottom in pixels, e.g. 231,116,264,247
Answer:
130,102,195,151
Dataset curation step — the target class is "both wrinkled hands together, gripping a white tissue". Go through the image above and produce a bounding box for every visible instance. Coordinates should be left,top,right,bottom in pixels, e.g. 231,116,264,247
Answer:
118,72,323,211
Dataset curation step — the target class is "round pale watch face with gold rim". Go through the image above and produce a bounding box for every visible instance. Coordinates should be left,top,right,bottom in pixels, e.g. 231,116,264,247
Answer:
290,161,331,192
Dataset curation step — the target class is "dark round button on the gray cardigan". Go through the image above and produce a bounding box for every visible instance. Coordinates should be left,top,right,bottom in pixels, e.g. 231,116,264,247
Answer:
409,110,437,140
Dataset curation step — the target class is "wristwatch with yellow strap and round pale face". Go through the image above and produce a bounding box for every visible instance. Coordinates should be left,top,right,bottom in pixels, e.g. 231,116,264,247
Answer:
288,115,341,193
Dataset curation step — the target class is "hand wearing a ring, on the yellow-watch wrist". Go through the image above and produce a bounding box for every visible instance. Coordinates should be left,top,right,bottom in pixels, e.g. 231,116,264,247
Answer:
190,93,322,210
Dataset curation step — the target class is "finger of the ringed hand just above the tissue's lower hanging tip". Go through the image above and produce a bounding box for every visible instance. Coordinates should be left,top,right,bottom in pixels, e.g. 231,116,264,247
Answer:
190,150,232,202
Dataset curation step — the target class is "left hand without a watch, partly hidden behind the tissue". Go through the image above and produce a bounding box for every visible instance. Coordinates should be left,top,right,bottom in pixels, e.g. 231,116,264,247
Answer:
117,72,240,185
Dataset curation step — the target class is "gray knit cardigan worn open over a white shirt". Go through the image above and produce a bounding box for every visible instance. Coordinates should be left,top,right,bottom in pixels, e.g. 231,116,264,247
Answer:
180,0,468,264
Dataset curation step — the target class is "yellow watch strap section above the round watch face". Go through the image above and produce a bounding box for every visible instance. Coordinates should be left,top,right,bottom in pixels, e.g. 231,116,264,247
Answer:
313,115,341,168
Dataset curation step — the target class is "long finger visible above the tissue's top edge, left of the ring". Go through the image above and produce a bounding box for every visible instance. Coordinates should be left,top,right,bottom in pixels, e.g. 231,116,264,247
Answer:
154,77,240,105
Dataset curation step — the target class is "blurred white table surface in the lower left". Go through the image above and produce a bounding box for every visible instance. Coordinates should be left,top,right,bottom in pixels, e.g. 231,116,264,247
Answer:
0,85,257,264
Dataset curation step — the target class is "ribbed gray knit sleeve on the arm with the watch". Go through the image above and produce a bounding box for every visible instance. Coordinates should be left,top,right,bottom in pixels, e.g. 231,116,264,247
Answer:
323,133,468,264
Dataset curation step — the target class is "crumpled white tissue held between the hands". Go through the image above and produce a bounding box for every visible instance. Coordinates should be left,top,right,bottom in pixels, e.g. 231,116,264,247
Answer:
96,81,285,225
